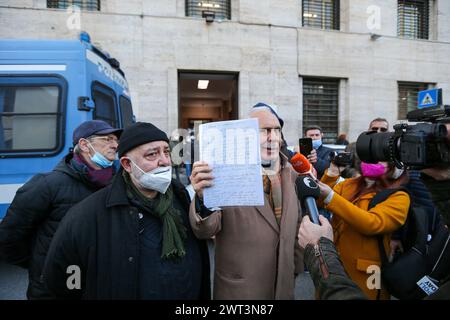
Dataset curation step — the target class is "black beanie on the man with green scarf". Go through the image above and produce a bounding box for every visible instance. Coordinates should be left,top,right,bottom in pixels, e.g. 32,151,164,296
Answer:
117,122,169,158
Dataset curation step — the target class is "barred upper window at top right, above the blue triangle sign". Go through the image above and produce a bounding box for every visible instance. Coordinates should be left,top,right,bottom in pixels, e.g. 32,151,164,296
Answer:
397,0,430,39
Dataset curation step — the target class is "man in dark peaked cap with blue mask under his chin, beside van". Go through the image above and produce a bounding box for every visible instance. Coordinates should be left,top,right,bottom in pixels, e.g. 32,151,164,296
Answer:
0,120,122,299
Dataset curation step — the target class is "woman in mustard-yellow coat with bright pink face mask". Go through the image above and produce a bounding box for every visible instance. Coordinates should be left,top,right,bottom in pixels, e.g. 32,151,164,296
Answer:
319,162,410,299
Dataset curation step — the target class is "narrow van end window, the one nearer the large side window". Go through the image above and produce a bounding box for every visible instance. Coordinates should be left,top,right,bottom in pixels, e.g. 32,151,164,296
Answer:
92,84,119,128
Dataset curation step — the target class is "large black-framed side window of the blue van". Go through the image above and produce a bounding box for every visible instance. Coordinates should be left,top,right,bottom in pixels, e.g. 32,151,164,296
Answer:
0,85,61,152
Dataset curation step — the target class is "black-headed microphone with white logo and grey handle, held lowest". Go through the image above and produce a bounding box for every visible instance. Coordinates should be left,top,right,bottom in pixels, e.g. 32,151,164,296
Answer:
295,176,320,225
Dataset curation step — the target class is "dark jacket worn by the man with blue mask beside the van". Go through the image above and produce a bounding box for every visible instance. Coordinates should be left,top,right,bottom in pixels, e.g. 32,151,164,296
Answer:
0,154,98,299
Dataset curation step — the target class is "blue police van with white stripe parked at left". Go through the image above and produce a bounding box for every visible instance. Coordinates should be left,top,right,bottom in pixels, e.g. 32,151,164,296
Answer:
0,33,134,220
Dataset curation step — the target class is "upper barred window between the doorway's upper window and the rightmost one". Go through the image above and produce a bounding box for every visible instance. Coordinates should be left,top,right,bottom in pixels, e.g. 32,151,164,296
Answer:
302,0,339,30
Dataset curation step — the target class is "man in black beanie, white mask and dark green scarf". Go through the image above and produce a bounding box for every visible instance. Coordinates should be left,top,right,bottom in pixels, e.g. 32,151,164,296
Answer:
44,122,210,300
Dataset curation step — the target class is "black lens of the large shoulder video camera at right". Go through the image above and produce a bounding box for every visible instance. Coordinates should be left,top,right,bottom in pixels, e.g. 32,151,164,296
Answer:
356,131,394,163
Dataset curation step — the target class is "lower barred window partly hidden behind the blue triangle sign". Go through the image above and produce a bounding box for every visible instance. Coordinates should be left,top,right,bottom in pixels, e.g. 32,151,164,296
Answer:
398,82,435,119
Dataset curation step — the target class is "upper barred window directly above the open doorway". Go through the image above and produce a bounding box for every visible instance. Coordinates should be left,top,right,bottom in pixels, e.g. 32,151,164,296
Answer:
186,0,231,20
